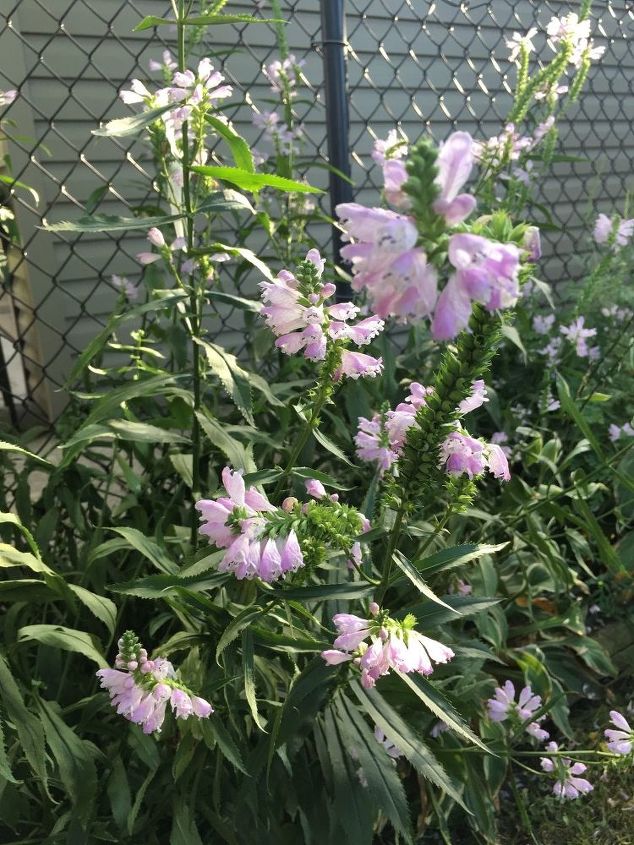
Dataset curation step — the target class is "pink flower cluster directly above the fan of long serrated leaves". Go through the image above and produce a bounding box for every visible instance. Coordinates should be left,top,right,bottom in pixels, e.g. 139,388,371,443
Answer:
321,602,454,689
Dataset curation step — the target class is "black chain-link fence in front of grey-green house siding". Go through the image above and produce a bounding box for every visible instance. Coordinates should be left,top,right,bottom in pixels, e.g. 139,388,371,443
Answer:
0,0,634,428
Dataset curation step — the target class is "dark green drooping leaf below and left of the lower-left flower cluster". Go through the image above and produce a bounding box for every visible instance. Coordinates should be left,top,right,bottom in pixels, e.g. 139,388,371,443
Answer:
37,699,97,822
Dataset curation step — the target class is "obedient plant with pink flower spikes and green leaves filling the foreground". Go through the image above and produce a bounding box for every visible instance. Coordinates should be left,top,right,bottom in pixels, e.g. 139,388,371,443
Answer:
0,2,632,845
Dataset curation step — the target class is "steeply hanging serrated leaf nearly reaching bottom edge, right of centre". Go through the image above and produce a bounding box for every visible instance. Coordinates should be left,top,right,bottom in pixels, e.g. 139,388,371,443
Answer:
335,695,411,842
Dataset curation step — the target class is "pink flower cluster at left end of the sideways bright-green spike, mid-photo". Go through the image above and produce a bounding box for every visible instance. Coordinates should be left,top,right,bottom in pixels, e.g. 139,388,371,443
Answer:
196,467,304,584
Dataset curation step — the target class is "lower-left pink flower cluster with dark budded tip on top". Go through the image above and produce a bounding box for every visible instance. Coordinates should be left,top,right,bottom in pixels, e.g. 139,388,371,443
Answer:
97,631,213,734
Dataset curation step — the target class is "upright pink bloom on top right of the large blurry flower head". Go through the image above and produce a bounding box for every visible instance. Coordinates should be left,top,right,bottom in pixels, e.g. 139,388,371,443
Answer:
434,132,476,226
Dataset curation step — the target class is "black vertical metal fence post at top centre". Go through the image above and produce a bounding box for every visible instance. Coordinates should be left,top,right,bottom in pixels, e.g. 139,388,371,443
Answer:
320,0,352,290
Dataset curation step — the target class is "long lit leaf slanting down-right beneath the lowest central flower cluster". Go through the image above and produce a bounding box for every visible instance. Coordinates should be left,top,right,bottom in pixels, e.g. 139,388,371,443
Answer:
350,681,466,809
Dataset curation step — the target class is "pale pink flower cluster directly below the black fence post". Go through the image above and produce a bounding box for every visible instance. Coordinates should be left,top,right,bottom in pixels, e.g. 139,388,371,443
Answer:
260,249,384,380
